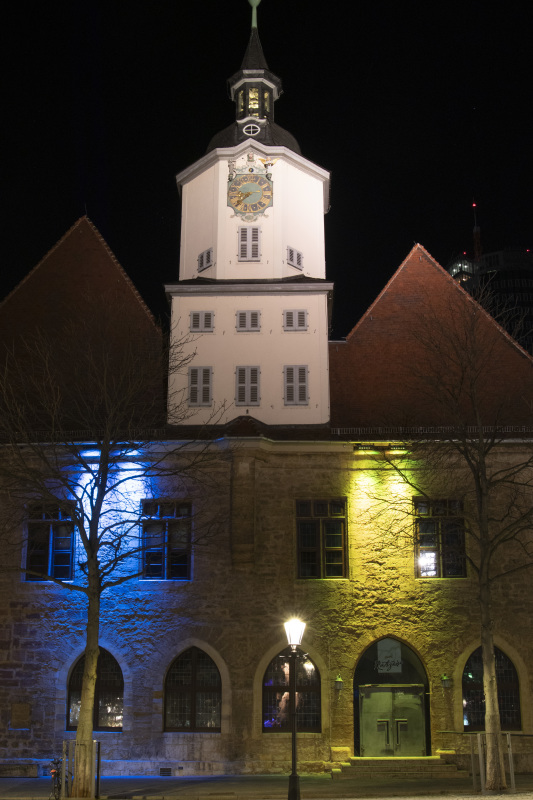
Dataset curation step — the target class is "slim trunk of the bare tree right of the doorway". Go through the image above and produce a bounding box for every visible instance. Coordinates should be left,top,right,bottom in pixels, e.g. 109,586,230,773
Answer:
480,574,507,791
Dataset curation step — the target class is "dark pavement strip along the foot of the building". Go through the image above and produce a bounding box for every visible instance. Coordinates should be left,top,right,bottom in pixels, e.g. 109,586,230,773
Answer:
0,775,533,800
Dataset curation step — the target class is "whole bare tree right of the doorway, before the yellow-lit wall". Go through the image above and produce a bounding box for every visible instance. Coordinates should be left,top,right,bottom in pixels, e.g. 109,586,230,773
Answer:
354,287,533,790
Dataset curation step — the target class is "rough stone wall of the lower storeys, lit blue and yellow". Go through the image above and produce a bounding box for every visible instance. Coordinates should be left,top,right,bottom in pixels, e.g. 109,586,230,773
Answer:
0,440,533,774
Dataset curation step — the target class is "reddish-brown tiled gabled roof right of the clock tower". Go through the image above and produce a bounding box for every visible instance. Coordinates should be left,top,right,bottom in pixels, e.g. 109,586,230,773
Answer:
329,244,533,429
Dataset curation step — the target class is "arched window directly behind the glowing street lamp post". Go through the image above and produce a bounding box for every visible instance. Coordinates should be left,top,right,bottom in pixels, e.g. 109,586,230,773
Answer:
263,647,321,733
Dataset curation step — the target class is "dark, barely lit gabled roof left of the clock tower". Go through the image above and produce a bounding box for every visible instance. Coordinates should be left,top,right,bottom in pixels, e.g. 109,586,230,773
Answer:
0,217,167,434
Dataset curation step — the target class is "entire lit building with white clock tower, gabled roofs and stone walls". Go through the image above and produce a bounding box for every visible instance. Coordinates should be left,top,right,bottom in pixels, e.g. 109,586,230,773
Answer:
0,0,533,775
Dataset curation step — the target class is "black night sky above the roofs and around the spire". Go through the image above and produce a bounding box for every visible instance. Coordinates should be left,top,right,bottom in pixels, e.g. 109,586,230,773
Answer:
0,0,533,337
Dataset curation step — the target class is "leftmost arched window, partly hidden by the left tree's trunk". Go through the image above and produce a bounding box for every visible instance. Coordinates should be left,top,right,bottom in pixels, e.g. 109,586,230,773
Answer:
67,647,124,731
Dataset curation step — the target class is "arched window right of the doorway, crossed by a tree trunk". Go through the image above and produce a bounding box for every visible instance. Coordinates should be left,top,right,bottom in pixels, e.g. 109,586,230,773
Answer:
463,647,522,731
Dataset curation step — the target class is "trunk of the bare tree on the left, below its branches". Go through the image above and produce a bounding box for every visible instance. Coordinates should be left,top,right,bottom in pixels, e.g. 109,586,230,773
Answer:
73,576,100,797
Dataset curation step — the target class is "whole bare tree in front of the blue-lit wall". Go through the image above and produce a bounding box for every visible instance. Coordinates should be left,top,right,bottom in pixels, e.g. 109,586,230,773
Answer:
0,296,227,797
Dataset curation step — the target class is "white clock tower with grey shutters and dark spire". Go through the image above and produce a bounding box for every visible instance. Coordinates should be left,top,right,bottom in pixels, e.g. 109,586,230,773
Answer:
166,0,333,425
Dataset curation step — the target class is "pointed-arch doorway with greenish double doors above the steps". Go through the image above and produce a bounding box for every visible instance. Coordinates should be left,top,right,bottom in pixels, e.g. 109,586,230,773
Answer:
354,638,431,758
